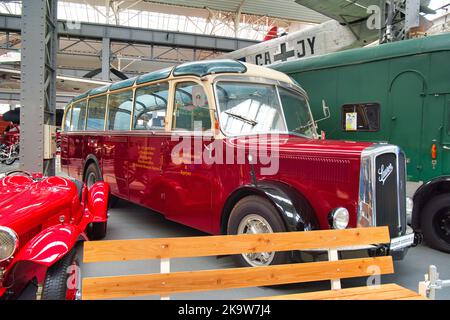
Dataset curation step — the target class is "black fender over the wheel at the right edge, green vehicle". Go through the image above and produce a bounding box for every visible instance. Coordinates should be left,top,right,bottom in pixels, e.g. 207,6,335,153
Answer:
411,176,450,230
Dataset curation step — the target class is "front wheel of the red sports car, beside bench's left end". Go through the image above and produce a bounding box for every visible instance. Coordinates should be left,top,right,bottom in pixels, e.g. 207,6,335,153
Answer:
42,246,81,300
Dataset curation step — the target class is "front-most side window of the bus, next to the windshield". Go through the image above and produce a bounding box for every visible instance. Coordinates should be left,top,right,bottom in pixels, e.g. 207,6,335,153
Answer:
173,82,211,131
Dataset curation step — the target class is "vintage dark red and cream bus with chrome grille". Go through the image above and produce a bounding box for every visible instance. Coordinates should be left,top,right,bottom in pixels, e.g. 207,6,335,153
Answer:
61,60,414,266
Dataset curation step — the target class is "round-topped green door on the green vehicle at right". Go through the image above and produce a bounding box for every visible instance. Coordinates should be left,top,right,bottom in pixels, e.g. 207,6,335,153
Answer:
381,71,426,181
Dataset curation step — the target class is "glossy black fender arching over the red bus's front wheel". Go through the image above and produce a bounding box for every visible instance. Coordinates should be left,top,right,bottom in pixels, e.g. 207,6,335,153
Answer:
222,181,319,233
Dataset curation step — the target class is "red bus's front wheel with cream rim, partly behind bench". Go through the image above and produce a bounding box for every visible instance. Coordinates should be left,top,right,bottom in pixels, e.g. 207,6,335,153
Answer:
227,196,289,267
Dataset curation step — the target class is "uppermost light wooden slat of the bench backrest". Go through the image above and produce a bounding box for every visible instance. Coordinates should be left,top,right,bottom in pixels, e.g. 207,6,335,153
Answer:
84,227,390,263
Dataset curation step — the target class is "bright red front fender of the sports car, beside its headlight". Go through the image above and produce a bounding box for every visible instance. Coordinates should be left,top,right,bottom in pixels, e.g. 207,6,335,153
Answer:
14,224,87,268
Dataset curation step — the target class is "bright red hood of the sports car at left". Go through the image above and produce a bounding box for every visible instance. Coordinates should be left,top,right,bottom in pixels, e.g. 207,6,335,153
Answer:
0,176,77,235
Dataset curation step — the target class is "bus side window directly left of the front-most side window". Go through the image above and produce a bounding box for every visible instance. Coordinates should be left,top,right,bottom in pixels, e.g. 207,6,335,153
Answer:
133,83,169,130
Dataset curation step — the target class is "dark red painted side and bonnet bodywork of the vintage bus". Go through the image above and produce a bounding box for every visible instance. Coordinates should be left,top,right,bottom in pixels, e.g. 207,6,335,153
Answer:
61,131,371,234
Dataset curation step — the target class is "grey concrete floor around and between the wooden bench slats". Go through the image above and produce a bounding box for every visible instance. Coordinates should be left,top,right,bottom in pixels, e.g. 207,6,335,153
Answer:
77,201,450,300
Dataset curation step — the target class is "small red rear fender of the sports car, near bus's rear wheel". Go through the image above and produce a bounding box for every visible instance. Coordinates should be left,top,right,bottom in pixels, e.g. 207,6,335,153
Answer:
87,181,110,222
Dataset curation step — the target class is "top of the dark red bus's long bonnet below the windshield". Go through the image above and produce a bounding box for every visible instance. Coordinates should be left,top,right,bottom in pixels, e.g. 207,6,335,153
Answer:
228,135,373,157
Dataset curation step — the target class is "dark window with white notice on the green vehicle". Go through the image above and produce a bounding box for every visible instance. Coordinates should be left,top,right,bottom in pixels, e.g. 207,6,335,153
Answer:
342,103,380,131
